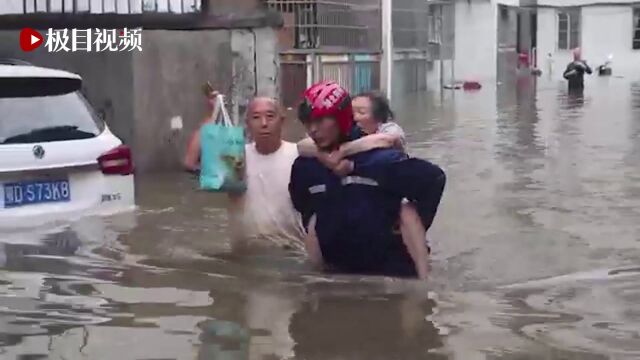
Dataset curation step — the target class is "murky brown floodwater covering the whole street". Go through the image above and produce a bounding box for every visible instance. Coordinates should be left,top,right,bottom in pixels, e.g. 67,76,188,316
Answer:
0,77,640,360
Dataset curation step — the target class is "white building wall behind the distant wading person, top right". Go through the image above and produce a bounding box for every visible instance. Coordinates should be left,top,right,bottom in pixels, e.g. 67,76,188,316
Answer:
538,5,640,79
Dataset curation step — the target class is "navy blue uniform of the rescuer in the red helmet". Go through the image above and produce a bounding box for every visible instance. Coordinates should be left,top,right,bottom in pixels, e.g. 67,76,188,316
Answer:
289,149,445,276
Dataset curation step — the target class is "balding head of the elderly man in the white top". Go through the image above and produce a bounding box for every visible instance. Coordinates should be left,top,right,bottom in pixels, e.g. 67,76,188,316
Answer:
247,96,284,154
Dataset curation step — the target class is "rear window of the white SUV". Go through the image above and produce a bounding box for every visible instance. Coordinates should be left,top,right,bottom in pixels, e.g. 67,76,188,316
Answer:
0,91,104,144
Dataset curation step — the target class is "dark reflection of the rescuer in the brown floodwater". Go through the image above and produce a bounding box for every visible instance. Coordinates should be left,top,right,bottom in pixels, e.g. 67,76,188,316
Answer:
290,294,445,359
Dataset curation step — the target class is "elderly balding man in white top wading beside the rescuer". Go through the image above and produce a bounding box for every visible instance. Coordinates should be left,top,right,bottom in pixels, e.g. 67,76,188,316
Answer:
185,97,304,250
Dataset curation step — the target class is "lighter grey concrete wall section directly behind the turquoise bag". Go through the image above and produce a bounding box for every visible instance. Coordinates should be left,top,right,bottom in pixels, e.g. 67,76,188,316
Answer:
128,30,232,171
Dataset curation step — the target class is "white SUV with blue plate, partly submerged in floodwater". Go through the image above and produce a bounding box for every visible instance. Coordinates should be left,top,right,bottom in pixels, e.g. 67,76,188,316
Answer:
0,60,134,229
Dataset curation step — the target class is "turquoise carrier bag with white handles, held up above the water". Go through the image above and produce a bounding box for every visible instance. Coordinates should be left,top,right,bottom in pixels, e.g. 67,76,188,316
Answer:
200,95,247,192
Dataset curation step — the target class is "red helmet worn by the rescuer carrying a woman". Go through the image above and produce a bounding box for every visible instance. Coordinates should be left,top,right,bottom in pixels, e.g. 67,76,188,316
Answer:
298,81,353,136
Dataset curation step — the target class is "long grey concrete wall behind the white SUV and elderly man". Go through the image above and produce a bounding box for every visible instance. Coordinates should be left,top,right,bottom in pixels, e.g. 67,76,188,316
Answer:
0,28,278,172
